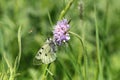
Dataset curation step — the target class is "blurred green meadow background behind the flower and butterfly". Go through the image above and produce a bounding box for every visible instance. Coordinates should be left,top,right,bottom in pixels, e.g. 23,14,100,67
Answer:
0,0,120,80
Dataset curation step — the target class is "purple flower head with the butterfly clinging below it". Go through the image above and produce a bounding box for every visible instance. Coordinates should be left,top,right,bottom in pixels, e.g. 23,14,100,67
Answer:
53,19,70,45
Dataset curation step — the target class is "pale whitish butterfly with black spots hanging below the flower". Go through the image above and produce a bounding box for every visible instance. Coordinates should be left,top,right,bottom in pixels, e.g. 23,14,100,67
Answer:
33,38,57,65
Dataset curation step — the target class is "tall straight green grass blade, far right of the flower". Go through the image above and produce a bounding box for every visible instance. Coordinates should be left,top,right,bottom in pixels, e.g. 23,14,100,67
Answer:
94,4,103,80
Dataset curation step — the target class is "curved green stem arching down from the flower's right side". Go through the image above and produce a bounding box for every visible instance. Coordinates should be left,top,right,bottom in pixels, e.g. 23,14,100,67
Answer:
69,31,87,80
